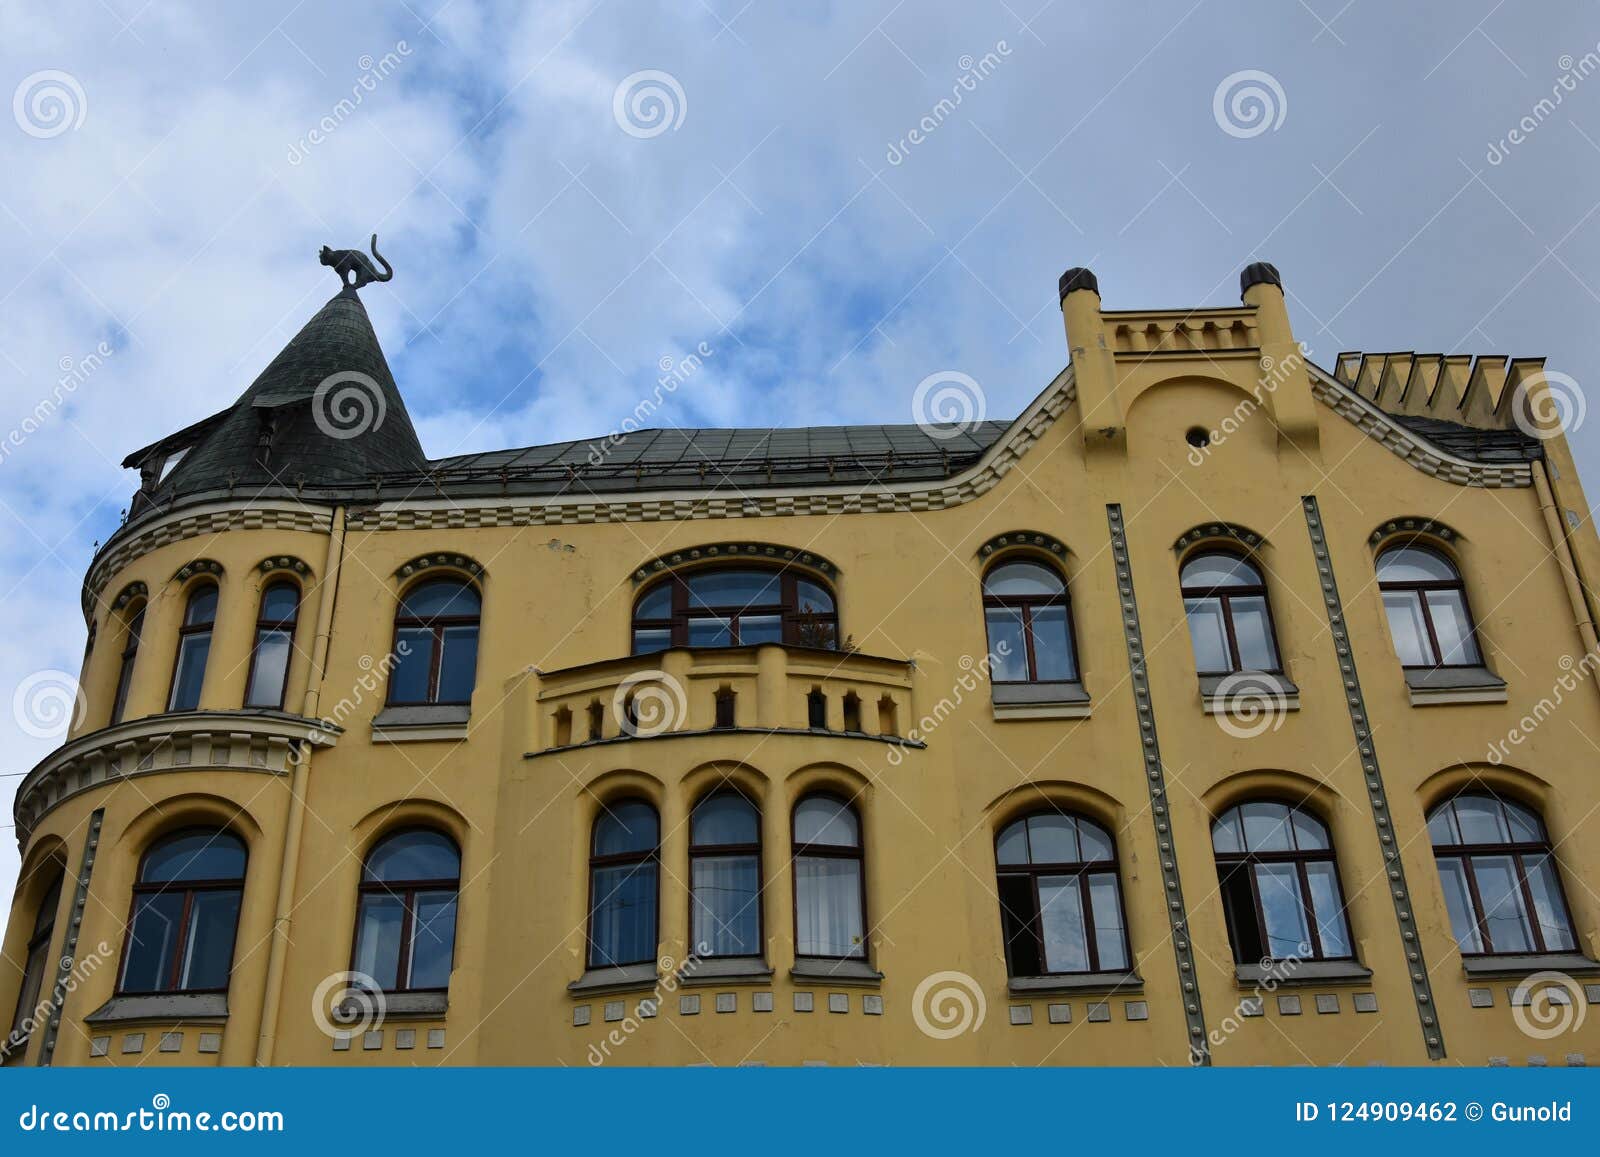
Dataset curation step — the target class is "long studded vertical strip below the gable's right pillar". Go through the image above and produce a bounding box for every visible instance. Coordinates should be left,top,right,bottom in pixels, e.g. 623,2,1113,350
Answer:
1301,494,1445,1061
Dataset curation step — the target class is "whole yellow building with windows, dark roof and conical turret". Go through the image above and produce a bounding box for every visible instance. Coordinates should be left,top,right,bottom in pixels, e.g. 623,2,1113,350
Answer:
0,264,1600,1066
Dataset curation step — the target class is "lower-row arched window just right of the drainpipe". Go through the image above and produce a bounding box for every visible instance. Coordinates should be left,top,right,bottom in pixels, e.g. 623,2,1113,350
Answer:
350,827,461,992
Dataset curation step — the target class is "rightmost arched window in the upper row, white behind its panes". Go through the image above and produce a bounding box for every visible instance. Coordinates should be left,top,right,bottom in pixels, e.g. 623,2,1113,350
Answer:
1378,544,1483,667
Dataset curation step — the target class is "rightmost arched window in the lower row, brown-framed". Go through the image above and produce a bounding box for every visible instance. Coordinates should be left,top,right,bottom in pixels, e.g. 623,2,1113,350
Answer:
1427,792,1578,955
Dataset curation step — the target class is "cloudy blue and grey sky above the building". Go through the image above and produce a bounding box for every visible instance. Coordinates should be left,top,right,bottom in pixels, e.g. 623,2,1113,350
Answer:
0,0,1600,895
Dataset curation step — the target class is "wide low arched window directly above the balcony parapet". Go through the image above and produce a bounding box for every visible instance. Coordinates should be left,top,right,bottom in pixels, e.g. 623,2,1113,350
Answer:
634,566,838,655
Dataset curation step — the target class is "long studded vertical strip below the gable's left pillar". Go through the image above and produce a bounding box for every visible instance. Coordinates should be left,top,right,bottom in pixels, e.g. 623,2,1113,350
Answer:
1106,502,1211,1064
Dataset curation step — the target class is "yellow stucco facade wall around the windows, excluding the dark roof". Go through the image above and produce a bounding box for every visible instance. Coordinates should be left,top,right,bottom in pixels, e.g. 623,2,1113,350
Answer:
0,267,1600,1066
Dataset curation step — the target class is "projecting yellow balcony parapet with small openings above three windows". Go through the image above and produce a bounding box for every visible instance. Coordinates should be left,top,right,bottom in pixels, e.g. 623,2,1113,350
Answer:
530,643,922,755
